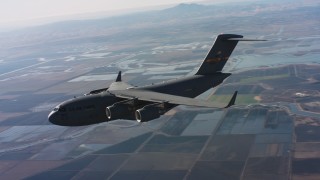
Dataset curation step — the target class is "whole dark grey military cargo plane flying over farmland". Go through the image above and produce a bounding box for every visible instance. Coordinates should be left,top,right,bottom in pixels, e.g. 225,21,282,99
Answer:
48,34,262,126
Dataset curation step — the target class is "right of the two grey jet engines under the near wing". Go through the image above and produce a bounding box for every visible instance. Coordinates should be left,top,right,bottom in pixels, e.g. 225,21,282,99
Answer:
135,104,164,122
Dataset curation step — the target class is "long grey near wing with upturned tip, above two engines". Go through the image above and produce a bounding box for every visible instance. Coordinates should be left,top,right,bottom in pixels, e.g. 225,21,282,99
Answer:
109,89,237,108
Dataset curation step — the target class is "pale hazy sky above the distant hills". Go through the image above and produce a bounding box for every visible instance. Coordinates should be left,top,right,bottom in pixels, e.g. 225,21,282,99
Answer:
0,0,204,23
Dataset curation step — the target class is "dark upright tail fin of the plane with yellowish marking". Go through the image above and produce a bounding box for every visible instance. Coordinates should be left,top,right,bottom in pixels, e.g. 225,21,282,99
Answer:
196,34,243,75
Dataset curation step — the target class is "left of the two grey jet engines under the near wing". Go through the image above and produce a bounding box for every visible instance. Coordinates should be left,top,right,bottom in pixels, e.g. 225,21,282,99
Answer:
106,99,136,120
